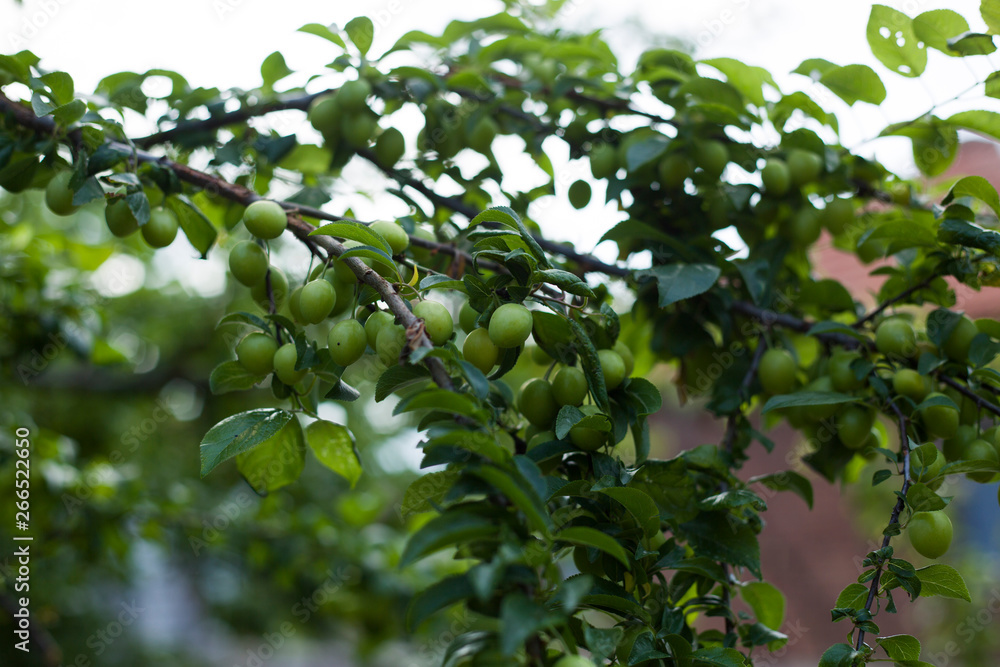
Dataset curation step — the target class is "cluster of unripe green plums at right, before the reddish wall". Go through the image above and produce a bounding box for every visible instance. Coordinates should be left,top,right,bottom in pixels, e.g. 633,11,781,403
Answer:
757,317,1000,558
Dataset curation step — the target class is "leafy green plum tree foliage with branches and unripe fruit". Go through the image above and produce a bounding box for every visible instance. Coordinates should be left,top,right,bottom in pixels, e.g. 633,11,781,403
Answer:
0,2,1000,666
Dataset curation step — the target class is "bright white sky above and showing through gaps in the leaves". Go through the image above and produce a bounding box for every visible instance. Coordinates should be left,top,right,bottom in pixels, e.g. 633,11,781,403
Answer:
0,0,1000,257
